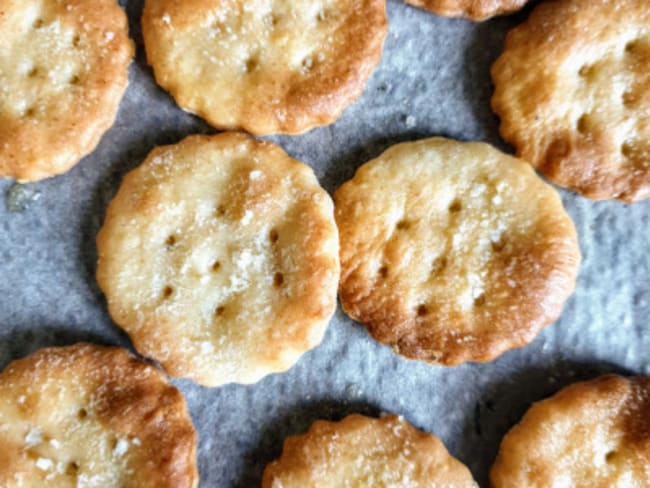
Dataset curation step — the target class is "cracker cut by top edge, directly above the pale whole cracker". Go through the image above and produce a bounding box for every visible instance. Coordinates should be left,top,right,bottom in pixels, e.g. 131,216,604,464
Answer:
142,0,387,135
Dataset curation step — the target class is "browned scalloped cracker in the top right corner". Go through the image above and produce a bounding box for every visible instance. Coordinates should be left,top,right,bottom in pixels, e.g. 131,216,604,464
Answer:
492,0,650,202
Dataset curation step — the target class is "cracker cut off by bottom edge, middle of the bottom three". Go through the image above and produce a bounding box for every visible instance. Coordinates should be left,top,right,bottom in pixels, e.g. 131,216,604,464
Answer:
262,415,478,488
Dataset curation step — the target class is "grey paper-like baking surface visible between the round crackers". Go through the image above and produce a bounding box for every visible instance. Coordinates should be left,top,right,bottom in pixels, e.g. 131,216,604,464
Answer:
0,0,650,487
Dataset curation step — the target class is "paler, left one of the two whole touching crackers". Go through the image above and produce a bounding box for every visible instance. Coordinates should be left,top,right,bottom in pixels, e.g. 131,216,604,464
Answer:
97,133,339,386
